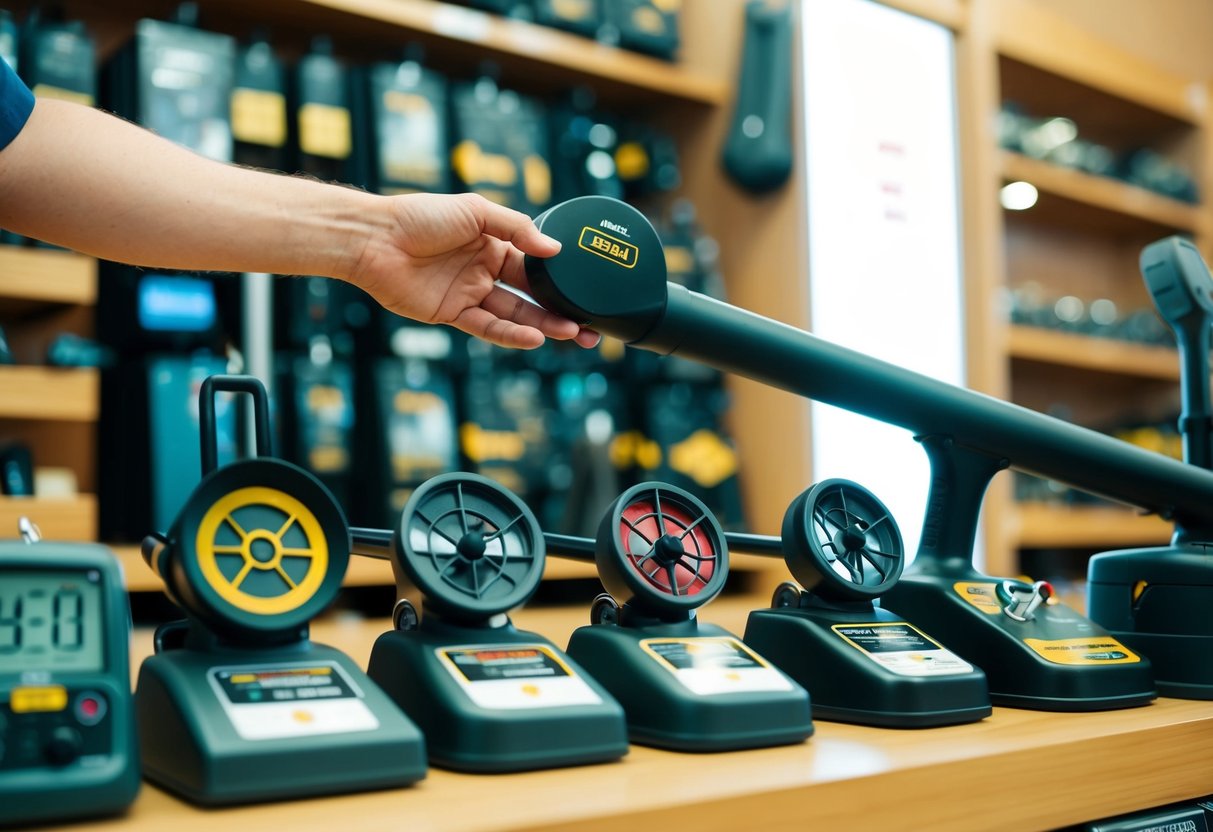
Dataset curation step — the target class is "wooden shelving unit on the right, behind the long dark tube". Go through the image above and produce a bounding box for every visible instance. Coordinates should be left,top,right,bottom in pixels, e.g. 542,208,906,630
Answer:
959,0,1209,574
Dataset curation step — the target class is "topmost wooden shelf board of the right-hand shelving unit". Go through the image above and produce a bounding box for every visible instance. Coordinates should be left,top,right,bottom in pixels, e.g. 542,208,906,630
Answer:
991,0,1207,129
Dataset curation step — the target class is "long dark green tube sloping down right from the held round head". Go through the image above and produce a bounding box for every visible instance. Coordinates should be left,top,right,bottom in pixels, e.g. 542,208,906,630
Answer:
640,284,1213,528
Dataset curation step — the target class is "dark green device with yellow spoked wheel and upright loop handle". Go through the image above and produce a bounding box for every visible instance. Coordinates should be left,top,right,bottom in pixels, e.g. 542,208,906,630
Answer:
136,376,426,805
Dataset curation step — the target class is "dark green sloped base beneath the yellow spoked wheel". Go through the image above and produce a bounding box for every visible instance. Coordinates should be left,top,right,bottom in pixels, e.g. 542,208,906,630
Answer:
138,632,426,805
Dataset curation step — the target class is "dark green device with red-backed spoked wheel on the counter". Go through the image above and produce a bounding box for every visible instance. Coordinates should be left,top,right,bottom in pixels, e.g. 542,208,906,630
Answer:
547,483,813,751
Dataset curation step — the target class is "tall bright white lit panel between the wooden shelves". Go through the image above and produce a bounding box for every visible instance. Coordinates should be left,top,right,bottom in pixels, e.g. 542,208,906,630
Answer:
801,0,964,567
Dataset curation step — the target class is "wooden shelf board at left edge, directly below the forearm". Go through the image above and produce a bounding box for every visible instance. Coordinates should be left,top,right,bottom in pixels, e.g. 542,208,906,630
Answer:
0,245,97,318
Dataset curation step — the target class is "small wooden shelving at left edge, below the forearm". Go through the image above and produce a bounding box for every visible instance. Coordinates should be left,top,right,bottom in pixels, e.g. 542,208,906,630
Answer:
0,245,99,540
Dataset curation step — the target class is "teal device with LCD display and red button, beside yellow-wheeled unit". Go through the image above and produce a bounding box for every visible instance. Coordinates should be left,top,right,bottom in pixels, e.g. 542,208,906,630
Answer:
0,541,139,826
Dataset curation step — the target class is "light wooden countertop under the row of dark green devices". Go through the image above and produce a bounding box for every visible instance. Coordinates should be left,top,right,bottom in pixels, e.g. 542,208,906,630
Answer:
52,598,1213,832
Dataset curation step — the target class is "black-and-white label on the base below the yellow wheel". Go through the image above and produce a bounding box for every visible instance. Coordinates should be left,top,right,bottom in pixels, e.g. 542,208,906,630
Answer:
206,662,380,740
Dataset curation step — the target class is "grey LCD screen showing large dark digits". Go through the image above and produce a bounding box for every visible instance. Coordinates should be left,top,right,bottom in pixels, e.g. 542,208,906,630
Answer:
0,570,106,676
